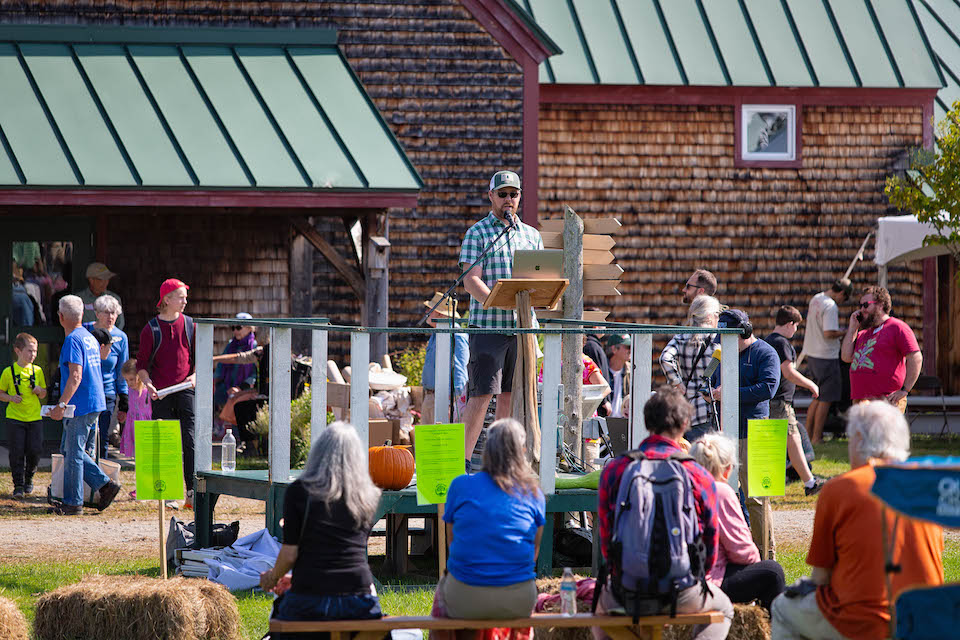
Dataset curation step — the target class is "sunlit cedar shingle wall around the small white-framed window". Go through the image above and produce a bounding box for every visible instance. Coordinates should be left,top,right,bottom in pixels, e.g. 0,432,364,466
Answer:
540,105,923,358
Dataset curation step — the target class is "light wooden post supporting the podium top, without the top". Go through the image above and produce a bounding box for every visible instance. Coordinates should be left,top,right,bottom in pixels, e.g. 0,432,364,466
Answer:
511,291,540,470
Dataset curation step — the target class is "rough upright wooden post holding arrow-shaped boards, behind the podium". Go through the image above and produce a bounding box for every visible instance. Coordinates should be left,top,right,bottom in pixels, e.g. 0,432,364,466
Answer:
560,207,583,456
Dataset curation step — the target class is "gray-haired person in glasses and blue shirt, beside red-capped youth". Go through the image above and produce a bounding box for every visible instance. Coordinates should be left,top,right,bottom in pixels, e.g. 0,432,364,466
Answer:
83,294,130,458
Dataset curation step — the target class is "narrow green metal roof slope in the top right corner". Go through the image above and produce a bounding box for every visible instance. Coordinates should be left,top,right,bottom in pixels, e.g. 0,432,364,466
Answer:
913,0,960,122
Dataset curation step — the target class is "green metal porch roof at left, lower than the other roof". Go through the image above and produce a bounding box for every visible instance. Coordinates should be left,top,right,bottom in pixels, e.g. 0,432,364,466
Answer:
0,25,422,191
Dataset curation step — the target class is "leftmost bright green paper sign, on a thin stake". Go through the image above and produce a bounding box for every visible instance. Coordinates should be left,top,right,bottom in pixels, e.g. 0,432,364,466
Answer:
133,420,183,500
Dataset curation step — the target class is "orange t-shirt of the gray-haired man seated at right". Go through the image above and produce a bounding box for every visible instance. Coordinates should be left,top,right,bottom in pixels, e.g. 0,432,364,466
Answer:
807,465,943,640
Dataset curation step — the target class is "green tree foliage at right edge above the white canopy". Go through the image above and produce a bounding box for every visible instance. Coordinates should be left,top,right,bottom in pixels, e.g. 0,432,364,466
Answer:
884,101,960,260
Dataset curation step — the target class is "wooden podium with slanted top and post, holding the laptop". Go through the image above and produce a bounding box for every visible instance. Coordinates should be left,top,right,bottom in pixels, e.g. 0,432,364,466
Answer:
483,278,570,469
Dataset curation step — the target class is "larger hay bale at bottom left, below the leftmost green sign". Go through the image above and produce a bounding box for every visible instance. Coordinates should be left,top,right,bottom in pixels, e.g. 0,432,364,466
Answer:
34,576,239,640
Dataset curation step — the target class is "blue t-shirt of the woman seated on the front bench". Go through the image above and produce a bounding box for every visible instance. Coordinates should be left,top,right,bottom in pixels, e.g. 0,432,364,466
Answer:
443,471,546,587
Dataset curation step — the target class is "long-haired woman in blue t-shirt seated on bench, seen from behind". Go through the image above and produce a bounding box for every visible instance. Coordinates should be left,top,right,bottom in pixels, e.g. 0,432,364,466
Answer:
438,418,546,619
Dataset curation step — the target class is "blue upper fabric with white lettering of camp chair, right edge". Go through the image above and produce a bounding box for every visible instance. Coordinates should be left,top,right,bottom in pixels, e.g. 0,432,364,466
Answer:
873,456,960,529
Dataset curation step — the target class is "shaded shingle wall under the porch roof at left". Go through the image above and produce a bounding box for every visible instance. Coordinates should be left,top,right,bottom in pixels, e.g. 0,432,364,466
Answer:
107,211,290,353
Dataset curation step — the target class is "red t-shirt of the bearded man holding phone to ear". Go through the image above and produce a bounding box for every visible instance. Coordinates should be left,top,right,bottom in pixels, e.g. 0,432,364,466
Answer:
850,318,920,400
